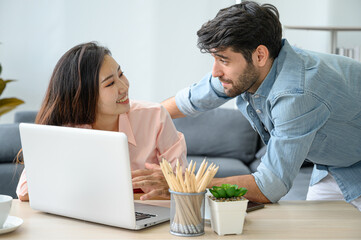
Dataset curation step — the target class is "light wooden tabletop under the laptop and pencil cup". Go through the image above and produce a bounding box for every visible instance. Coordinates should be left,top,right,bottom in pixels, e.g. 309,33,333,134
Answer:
0,200,361,240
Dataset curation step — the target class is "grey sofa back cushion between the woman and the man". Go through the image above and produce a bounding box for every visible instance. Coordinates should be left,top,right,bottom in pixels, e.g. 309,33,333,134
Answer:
173,108,258,163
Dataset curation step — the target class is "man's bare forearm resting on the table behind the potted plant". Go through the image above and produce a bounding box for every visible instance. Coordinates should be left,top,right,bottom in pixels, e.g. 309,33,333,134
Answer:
208,175,271,203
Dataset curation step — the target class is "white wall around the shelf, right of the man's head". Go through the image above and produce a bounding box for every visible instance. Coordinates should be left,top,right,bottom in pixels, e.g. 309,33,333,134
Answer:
257,0,361,53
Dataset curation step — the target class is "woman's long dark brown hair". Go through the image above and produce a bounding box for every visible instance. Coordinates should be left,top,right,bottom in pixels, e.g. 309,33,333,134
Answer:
16,42,111,163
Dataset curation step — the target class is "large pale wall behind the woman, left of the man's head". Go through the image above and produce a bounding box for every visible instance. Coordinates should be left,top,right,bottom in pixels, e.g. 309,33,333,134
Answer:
0,0,234,123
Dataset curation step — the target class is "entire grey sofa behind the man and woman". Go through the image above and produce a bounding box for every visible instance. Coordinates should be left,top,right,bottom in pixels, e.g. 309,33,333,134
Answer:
0,108,312,200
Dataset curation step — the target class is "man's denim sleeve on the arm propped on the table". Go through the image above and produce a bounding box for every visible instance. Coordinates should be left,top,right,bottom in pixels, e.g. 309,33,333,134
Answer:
252,94,330,202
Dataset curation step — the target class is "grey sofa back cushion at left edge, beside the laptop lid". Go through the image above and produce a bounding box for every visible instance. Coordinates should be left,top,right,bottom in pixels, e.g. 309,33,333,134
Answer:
0,123,21,163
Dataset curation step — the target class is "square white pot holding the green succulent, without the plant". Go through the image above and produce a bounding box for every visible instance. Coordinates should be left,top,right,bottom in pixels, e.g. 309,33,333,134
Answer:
208,197,248,235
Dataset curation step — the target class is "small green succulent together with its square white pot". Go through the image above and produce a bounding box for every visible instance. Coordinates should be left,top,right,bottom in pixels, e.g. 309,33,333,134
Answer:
208,184,248,235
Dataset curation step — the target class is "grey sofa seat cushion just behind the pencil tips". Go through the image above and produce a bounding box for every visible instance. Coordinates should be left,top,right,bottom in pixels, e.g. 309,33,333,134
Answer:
187,155,251,177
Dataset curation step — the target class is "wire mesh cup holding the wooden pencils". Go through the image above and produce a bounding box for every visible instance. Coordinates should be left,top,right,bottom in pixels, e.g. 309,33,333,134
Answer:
169,190,206,237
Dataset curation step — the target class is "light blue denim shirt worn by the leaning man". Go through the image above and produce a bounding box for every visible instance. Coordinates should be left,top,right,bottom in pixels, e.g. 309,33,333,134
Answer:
175,40,361,202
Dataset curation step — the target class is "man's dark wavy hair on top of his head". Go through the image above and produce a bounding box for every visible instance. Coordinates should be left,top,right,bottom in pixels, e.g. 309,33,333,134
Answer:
197,1,282,63
